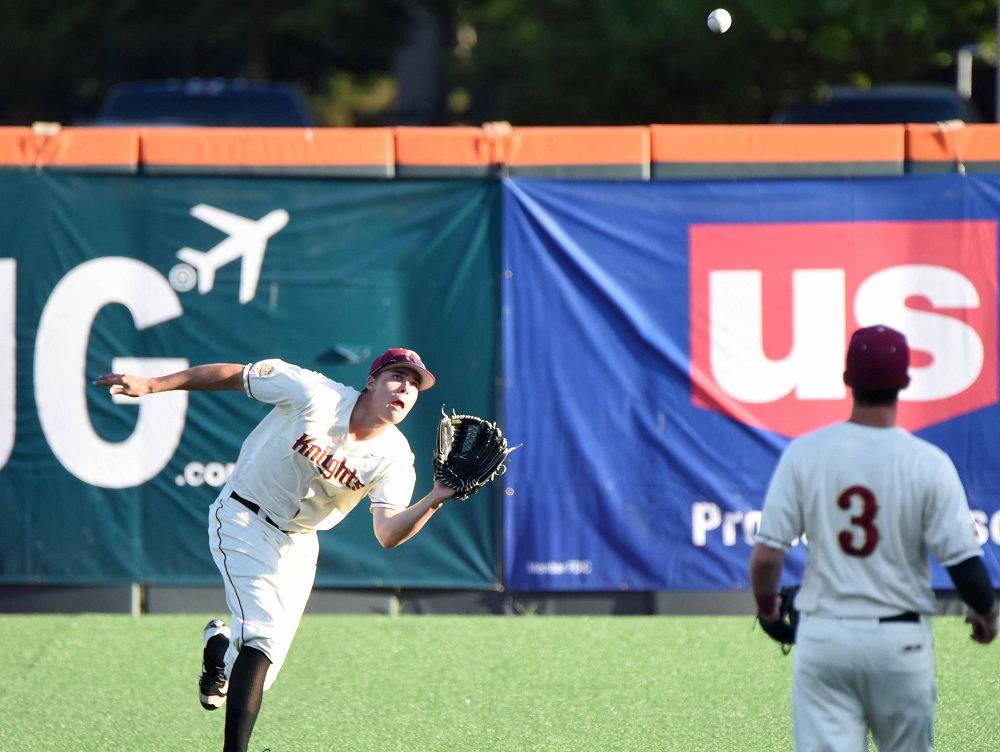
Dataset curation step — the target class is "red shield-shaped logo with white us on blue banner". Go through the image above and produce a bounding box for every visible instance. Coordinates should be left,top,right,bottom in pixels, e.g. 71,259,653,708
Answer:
690,220,997,437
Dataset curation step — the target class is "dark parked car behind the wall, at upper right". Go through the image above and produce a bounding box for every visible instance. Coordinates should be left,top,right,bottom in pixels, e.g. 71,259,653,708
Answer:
771,84,982,125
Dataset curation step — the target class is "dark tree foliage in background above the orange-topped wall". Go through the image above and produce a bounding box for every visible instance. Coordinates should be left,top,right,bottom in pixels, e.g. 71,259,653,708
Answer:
0,0,997,125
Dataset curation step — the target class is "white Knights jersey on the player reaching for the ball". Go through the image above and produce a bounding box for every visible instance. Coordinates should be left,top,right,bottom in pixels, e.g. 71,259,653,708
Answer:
229,360,416,532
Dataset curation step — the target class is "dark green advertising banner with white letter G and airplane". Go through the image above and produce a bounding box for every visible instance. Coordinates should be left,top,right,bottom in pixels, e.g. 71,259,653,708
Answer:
0,172,500,589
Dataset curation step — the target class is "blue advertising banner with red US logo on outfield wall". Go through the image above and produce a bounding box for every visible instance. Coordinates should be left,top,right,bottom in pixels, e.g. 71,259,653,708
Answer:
502,175,1000,591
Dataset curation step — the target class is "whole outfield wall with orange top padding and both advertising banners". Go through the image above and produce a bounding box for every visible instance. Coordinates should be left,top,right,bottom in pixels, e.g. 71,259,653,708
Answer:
0,124,1000,613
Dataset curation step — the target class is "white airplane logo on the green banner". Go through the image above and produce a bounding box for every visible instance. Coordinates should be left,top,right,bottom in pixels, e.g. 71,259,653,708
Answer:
177,204,288,304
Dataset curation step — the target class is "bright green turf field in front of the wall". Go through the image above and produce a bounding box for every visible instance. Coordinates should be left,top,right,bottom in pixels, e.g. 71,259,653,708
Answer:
0,615,1000,752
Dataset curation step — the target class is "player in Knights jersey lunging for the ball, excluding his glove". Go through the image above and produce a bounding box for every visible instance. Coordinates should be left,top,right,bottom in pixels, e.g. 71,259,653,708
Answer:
94,348,455,752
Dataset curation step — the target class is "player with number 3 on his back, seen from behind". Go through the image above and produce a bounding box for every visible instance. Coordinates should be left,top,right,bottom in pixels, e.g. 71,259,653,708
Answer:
750,326,997,752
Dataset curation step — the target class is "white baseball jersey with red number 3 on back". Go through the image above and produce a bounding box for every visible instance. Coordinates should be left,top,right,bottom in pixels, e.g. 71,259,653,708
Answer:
756,422,982,618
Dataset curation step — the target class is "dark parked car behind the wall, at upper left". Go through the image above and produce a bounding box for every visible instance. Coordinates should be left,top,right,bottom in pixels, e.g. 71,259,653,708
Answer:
76,78,315,128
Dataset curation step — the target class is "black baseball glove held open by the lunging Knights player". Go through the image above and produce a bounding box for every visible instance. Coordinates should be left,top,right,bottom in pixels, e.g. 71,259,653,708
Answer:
434,406,517,501
